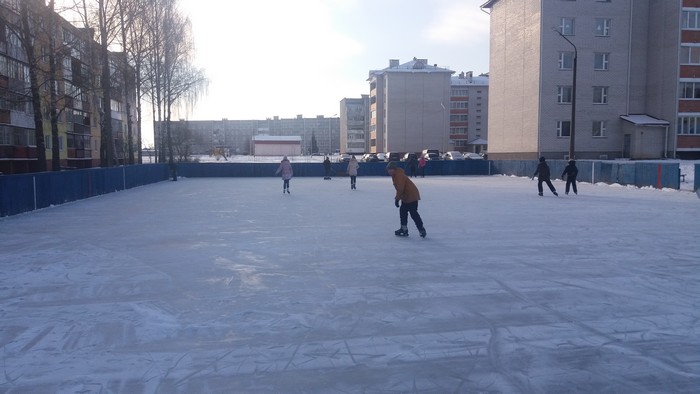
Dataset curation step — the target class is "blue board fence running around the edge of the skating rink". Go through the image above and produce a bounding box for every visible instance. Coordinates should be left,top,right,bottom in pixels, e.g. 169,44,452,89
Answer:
0,160,688,217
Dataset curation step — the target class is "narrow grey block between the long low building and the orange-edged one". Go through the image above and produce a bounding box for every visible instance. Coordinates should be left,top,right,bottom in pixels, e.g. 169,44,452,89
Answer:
340,94,369,155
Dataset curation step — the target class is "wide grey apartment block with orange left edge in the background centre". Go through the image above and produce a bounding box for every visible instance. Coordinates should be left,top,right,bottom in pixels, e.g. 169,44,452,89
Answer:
367,58,454,153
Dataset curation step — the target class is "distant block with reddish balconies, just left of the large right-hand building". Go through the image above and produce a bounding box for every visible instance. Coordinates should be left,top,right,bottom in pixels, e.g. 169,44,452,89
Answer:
449,71,489,153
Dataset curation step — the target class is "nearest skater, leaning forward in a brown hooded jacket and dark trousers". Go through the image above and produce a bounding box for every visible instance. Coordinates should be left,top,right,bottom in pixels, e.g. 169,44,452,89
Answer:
386,161,426,238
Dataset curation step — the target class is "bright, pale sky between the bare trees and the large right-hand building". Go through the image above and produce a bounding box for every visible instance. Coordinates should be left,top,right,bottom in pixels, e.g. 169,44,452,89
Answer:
172,0,489,120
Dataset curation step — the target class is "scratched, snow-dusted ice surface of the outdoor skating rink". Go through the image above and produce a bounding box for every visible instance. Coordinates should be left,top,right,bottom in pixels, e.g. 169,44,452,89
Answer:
0,176,700,394
